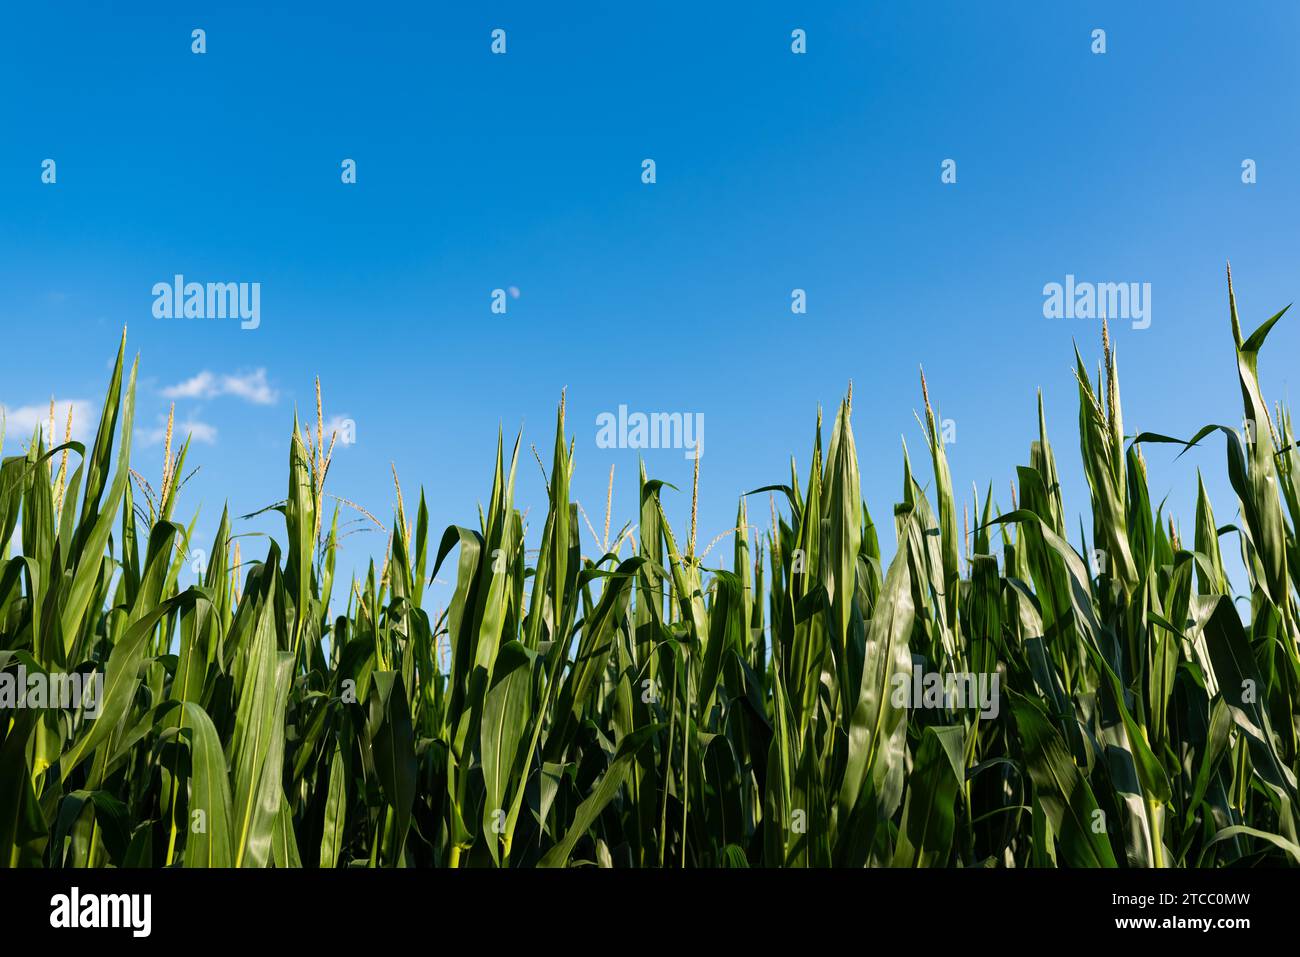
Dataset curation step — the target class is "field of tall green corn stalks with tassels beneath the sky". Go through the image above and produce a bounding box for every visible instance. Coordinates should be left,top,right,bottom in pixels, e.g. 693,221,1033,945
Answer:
0,269,1300,869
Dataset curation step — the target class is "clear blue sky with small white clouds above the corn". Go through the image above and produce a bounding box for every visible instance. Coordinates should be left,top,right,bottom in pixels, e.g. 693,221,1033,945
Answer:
0,1,1300,602
